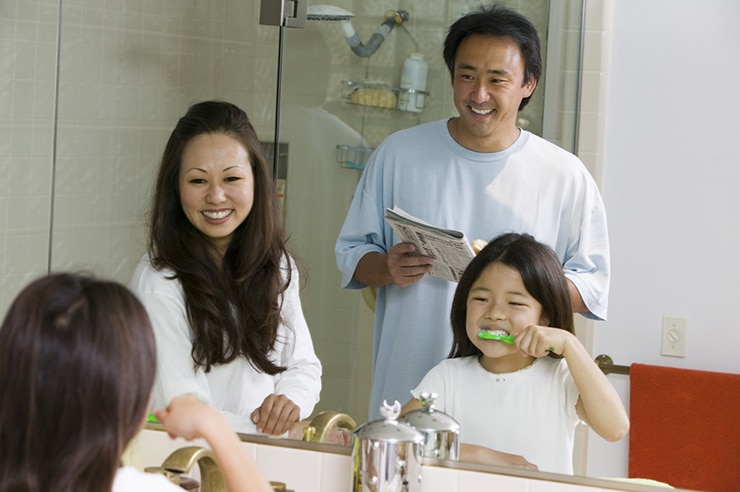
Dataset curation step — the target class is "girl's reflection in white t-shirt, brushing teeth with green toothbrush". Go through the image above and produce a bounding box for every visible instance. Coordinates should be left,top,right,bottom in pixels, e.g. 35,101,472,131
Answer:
403,233,629,474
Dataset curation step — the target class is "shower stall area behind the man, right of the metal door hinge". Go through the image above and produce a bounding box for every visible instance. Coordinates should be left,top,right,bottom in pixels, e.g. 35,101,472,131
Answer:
260,0,583,421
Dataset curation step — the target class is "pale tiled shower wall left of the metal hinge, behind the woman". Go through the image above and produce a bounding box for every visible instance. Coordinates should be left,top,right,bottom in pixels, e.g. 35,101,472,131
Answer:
0,0,277,313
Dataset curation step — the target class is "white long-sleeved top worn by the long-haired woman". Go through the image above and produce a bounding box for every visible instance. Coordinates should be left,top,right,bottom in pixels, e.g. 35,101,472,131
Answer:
129,255,321,434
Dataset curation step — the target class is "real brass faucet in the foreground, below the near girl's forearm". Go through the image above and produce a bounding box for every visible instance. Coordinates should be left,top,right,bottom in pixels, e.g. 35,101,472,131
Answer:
144,446,226,492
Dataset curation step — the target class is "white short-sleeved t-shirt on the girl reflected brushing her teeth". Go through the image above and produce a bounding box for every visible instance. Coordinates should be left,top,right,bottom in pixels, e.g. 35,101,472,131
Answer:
416,356,580,474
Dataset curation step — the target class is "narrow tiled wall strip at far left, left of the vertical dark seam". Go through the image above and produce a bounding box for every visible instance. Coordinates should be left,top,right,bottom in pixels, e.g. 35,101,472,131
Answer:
0,0,59,315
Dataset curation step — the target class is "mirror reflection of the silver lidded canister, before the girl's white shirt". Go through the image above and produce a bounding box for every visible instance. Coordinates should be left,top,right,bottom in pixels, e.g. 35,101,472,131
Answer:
398,391,460,460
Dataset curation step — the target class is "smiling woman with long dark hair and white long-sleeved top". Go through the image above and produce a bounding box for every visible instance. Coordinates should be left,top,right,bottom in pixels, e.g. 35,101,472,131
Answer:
130,101,321,435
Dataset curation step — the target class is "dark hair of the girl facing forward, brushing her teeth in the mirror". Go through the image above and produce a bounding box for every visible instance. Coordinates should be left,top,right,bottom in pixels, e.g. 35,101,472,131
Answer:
449,233,575,358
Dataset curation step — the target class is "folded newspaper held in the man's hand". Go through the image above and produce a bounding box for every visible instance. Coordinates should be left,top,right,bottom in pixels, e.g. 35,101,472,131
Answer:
385,207,475,282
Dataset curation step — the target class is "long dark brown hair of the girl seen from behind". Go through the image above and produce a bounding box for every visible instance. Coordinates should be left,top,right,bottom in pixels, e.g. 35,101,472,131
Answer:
0,274,156,492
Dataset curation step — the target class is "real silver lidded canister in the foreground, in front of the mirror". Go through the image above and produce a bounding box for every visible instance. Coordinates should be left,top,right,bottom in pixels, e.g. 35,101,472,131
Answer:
352,401,424,492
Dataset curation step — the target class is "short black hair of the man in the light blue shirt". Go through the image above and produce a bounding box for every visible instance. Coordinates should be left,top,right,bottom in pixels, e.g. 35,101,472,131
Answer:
442,5,542,111
